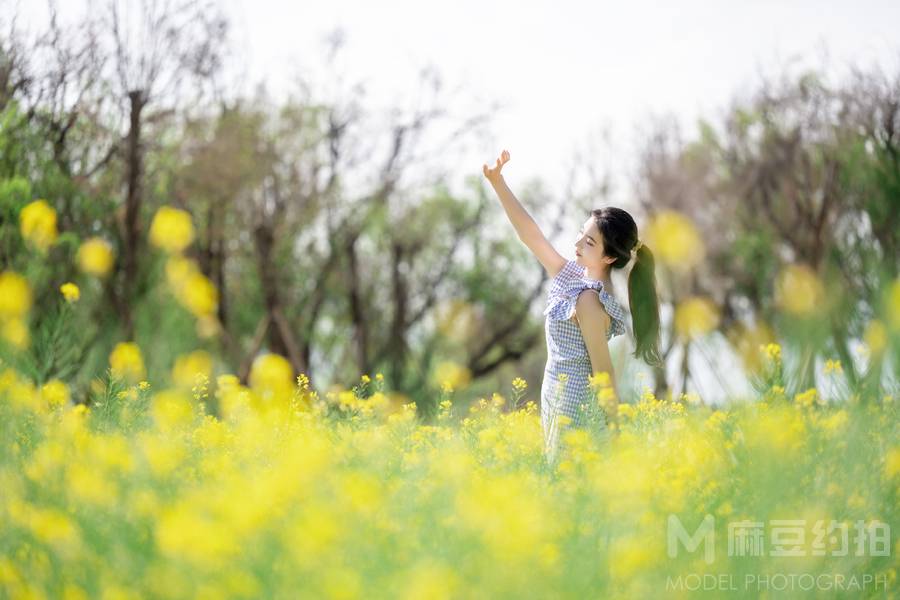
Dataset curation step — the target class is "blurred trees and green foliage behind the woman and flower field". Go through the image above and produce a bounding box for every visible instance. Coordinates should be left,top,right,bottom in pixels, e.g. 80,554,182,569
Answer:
0,2,900,409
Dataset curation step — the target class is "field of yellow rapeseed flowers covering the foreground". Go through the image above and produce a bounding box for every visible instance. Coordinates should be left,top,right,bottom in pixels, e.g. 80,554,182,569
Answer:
0,364,900,598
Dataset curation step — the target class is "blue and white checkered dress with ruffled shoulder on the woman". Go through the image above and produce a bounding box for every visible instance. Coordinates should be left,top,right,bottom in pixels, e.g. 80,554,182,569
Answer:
541,260,626,451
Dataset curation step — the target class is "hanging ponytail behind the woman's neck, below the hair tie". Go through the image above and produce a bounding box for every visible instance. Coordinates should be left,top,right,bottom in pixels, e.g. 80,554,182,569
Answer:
628,244,663,367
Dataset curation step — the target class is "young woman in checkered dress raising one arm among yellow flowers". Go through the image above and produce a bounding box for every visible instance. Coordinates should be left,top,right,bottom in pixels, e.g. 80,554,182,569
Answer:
483,150,661,456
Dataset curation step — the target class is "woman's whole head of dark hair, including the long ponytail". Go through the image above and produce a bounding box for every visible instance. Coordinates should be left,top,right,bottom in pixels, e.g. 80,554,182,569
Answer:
591,206,662,366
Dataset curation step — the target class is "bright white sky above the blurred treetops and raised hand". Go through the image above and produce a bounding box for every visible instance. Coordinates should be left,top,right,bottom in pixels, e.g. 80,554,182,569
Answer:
228,0,900,202
